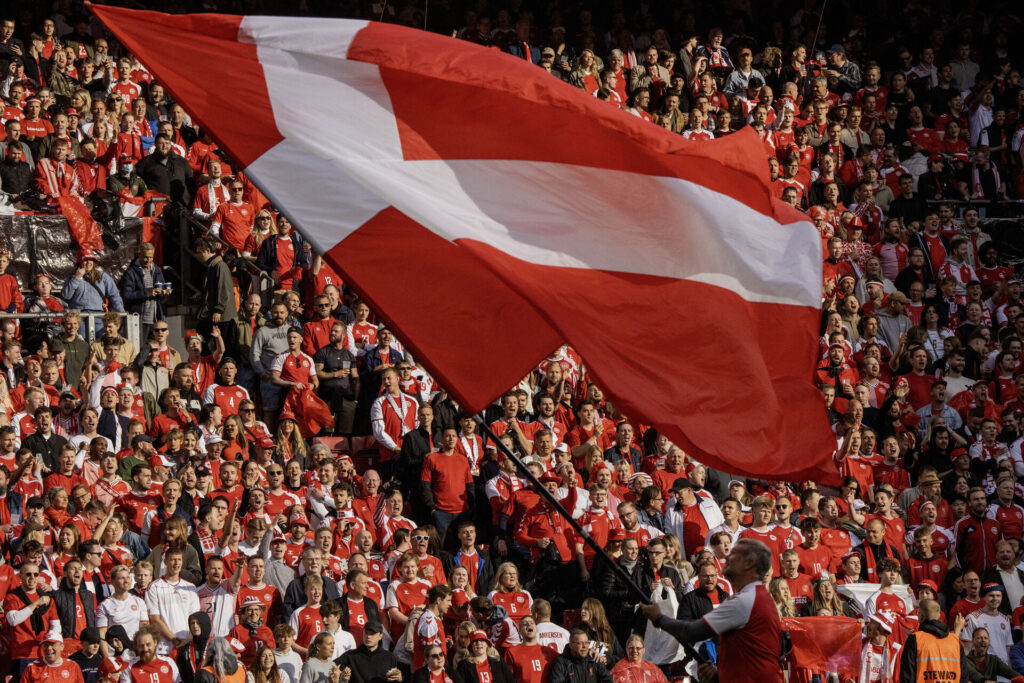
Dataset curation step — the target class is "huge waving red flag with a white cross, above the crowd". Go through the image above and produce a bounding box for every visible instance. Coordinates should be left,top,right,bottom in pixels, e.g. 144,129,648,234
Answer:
91,5,836,479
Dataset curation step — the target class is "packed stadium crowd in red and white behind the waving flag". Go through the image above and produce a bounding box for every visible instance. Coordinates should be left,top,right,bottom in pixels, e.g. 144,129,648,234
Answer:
0,2,1024,683
